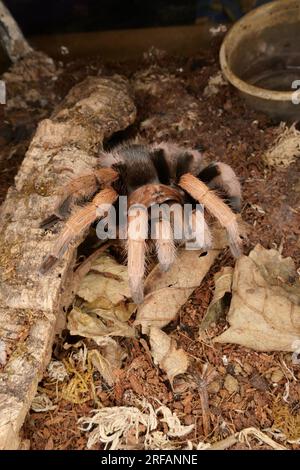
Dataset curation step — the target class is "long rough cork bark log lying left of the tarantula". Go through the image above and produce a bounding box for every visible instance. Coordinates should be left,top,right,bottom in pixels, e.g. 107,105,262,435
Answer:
0,76,136,449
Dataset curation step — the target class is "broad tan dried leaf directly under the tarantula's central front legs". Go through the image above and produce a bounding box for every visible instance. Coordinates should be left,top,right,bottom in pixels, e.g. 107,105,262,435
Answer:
135,230,226,334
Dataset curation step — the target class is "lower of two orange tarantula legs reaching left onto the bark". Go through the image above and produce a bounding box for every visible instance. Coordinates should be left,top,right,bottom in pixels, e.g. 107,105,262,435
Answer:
40,188,118,274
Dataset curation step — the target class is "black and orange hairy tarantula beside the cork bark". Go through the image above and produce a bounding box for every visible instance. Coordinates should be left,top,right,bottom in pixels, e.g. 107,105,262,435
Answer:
40,143,242,303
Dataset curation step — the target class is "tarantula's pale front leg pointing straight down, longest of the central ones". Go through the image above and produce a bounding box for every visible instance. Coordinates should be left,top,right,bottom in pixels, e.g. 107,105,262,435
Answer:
127,205,148,304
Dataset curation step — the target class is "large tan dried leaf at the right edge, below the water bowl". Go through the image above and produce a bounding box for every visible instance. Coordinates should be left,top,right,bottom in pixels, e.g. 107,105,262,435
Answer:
214,245,300,351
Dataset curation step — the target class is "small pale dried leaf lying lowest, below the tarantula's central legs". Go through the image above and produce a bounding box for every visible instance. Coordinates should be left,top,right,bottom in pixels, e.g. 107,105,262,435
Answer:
150,327,189,384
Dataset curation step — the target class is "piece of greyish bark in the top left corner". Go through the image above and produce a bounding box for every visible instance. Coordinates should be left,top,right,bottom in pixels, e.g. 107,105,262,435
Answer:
0,1,32,62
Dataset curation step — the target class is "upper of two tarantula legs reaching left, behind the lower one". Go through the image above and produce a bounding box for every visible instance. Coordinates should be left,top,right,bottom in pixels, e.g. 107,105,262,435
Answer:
40,168,118,229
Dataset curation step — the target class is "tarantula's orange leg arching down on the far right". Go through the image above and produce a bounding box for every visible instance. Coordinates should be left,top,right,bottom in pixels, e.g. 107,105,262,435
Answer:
179,173,242,258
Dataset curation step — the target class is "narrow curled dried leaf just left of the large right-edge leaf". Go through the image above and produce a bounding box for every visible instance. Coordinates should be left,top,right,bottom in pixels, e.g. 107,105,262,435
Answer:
200,266,233,331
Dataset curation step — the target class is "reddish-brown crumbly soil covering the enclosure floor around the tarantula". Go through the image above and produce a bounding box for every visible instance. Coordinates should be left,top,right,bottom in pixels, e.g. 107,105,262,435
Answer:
0,35,300,449
